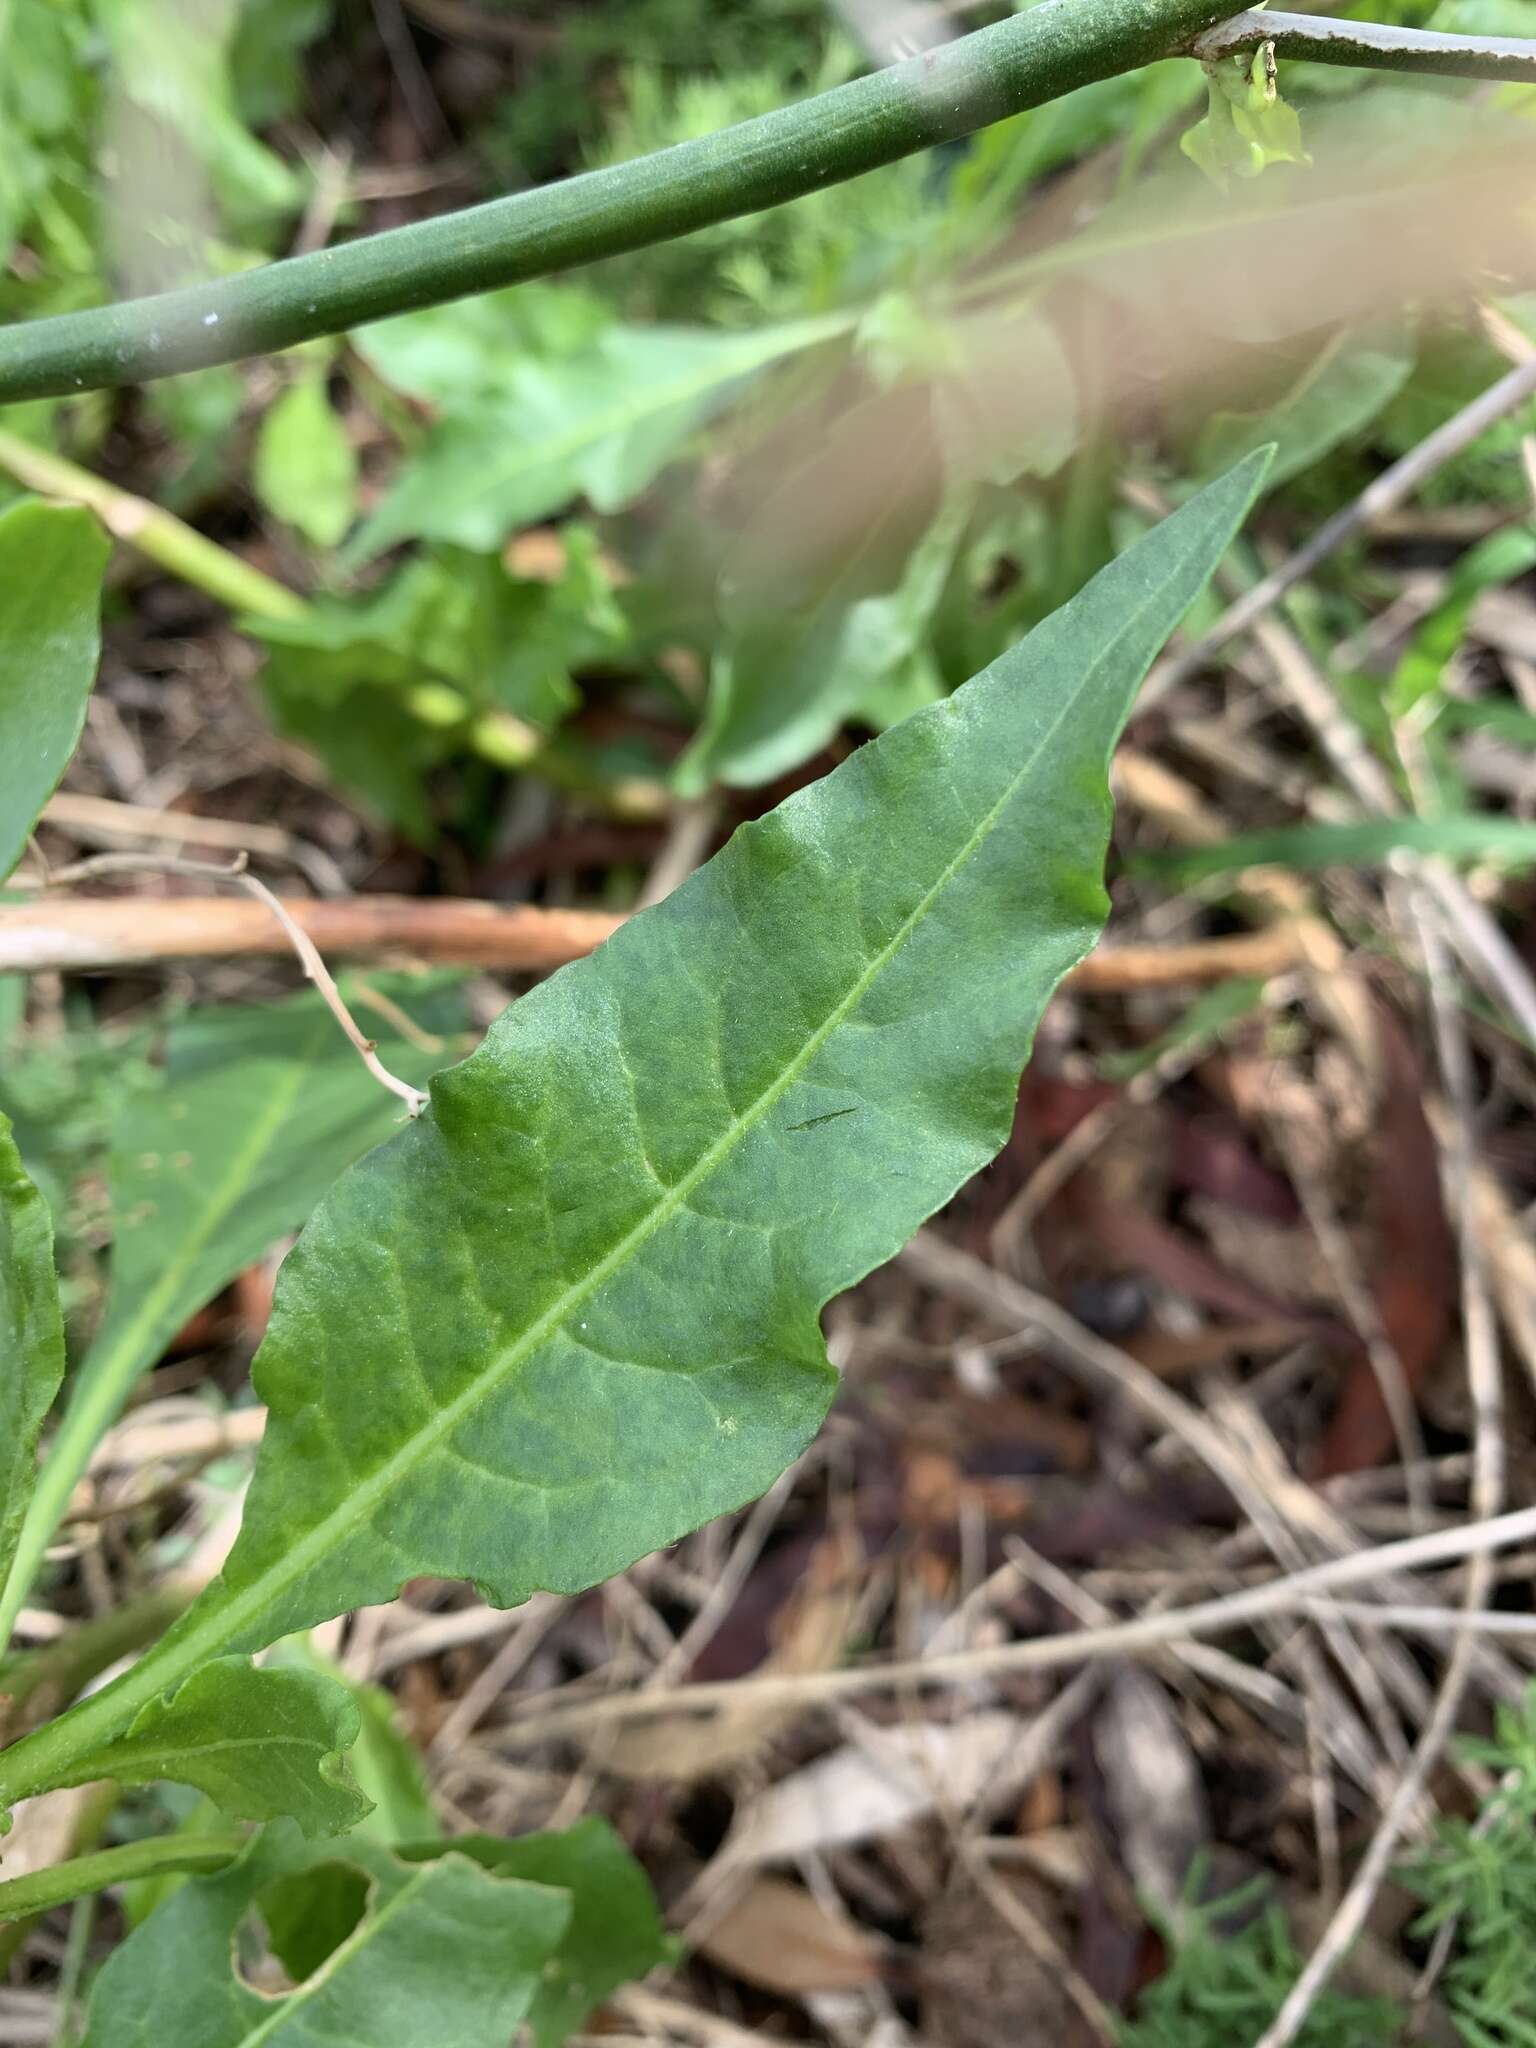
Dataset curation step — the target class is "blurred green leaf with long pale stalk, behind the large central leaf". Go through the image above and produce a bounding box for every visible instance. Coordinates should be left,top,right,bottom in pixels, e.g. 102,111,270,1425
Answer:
0,977,461,1636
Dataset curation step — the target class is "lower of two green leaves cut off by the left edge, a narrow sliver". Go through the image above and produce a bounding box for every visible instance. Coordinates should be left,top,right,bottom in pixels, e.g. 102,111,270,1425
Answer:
0,1114,63,1613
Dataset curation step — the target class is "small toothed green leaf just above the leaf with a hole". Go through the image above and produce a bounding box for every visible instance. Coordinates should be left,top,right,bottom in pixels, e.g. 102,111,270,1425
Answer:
42,1657,369,1835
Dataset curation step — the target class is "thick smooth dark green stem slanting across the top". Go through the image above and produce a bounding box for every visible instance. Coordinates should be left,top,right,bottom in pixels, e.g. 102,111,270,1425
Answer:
0,0,1227,403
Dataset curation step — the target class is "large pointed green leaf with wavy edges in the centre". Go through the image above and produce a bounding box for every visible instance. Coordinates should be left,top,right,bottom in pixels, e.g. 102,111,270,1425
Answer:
93,457,1264,1679
